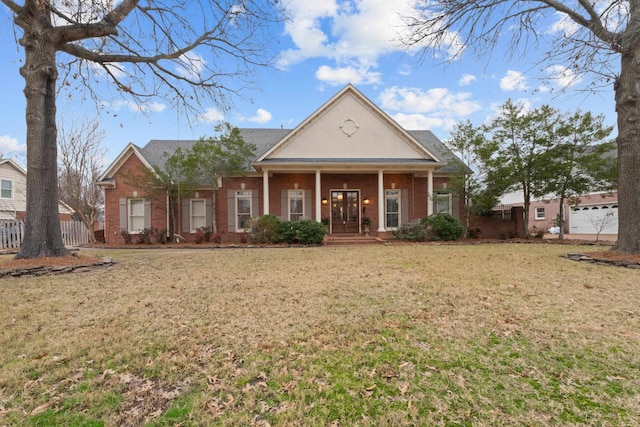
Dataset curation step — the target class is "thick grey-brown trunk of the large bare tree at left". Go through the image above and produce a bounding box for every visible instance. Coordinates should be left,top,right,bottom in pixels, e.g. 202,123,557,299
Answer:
16,18,68,258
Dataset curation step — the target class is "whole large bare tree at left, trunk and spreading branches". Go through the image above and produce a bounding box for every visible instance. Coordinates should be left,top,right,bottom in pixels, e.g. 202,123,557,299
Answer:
0,0,279,258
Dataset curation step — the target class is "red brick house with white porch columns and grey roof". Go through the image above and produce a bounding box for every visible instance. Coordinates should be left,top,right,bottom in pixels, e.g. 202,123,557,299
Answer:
98,85,460,243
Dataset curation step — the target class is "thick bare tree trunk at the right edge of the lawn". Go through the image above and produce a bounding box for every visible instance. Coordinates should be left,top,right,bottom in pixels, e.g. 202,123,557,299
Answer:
612,45,640,253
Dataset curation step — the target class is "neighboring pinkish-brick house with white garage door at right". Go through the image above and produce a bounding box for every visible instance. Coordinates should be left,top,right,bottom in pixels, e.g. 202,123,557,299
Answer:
501,191,618,240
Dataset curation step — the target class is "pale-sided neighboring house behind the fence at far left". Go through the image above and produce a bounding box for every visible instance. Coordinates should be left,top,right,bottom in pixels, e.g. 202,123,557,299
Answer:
0,158,73,220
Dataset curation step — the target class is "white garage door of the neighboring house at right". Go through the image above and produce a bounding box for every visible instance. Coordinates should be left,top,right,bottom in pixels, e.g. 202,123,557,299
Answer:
569,203,618,234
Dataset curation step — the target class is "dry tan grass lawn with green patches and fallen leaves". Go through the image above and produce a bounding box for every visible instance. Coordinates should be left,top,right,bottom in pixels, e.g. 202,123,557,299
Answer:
0,244,640,426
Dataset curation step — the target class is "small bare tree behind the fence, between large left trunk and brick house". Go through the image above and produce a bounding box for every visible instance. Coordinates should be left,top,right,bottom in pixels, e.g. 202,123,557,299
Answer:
58,119,106,243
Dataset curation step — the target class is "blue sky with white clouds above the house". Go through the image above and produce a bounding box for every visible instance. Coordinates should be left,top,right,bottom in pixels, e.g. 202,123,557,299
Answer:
0,0,616,167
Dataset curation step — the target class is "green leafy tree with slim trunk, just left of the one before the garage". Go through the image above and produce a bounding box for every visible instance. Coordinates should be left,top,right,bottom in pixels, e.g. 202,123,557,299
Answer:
482,100,558,236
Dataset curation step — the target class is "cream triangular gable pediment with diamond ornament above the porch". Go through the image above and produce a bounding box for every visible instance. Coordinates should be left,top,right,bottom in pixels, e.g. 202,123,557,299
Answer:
258,85,439,162
